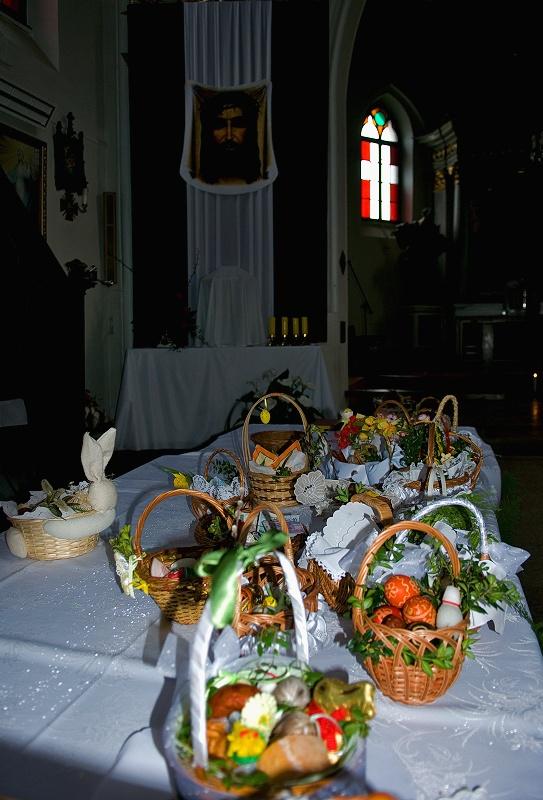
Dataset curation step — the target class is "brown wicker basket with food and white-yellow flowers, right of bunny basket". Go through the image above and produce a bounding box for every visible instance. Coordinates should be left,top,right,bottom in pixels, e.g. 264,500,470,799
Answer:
109,489,233,625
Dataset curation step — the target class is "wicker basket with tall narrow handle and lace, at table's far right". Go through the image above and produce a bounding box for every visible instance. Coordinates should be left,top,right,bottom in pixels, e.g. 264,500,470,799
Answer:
401,394,483,495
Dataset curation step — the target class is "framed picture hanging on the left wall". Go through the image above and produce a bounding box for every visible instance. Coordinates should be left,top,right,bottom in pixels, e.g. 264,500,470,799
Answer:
0,123,47,238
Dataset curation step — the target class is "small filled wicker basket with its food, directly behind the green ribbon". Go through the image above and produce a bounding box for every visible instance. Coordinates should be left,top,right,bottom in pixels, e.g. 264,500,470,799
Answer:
232,503,318,636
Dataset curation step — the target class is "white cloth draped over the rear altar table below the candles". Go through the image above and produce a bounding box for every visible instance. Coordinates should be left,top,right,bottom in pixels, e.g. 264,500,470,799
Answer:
115,345,339,450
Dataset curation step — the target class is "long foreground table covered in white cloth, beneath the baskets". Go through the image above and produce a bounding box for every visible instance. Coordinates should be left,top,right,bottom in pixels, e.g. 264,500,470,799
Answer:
0,430,543,800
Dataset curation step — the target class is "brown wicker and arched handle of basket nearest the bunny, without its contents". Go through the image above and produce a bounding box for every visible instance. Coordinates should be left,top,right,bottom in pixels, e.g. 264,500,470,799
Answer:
132,489,232,625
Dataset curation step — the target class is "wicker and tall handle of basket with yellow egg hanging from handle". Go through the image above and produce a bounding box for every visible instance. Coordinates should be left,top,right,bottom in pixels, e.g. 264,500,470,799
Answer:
242,392,309,508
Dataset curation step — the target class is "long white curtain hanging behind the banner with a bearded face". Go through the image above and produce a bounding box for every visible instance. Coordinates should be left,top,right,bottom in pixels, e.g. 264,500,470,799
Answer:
184,0,273,332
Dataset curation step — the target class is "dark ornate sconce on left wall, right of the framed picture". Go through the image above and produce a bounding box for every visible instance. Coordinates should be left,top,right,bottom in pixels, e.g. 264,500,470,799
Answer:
53,111,87,222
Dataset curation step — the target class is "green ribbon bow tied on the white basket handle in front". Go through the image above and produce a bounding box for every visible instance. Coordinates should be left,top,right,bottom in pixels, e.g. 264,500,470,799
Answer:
194,531,288,628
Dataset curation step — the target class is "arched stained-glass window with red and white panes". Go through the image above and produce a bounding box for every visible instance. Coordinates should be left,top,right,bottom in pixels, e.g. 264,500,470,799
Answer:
360,107,400,222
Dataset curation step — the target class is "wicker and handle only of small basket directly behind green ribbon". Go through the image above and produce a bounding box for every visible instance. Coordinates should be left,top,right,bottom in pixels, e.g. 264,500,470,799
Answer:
232,503,318,636
